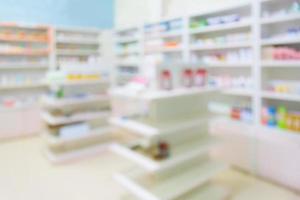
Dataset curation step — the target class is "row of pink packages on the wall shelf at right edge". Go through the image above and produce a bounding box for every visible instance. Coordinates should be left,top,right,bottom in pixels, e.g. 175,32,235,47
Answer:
264,47,300,60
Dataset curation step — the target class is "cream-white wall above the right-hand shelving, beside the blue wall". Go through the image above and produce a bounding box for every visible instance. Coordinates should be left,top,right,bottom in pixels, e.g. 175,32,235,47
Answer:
115,0,247,28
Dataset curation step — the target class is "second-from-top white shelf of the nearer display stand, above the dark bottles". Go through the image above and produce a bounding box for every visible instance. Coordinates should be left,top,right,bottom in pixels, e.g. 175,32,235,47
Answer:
109,115,208,137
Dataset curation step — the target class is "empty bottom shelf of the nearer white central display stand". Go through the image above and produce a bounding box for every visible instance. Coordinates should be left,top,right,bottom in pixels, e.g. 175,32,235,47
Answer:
114,162,227,200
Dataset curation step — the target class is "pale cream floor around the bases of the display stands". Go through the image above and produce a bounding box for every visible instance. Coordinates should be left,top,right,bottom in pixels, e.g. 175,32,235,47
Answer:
0,138,300,200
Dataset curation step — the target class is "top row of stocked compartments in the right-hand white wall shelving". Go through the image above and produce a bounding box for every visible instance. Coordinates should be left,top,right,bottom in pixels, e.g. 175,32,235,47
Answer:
116,0,300,43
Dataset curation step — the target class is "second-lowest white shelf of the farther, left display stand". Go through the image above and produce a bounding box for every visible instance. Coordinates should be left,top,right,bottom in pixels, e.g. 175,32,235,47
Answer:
45,127,114,146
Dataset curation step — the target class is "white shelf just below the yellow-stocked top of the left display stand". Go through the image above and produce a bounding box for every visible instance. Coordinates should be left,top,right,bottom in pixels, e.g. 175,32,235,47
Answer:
43,95,109,108
